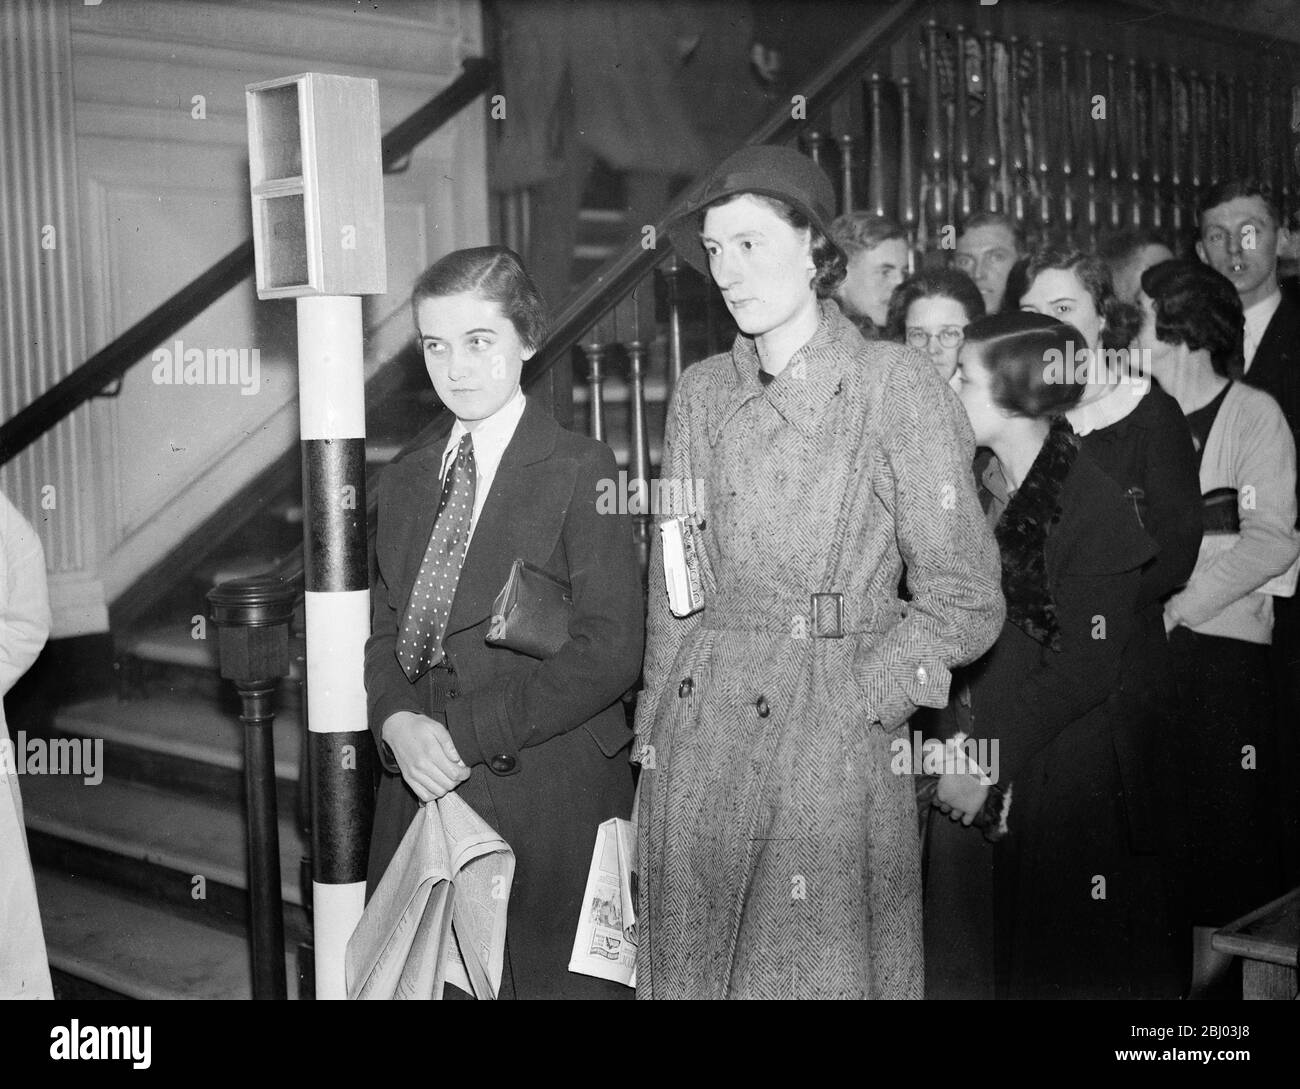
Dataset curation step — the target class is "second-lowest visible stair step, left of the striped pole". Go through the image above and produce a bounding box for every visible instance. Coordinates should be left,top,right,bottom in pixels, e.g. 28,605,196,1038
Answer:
22,776,308,906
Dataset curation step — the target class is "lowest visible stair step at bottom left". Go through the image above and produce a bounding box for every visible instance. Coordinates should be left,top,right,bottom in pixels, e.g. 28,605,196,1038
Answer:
36,868,298,999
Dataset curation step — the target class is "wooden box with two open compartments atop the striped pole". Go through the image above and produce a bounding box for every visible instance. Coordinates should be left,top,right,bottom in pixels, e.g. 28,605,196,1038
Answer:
246,71,387,299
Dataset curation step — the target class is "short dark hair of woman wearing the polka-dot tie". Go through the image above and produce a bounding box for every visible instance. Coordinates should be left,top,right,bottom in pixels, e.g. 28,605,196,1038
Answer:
411,246,550,351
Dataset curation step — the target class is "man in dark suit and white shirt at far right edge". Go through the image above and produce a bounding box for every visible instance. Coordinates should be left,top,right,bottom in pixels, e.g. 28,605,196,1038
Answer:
1196,178,1300,885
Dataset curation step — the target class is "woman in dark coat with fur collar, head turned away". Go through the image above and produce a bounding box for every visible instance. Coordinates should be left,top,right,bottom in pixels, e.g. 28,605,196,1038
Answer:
927,313,1158,998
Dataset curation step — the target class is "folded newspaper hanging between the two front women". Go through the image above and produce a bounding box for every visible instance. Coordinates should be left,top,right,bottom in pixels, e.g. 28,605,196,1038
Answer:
569,817,637,988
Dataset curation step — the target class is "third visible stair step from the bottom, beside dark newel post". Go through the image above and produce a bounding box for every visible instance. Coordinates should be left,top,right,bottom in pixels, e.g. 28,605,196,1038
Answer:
55,697,303,782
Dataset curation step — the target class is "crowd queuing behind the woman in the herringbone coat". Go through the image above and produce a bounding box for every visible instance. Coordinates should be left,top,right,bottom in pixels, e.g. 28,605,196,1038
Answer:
832,179,1300,997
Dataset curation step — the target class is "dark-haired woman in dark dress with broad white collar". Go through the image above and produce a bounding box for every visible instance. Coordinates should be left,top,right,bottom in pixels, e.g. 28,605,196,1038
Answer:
1021,247,1201,998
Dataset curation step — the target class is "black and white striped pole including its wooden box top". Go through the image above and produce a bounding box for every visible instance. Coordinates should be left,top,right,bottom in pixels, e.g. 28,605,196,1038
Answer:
247,73,387,998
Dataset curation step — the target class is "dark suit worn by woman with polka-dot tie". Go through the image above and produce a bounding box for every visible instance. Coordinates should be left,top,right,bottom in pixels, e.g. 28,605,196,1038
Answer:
365,398,645,998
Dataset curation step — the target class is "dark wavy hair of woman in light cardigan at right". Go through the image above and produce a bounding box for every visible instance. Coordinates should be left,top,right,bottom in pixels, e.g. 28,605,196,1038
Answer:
1141,260,1245,377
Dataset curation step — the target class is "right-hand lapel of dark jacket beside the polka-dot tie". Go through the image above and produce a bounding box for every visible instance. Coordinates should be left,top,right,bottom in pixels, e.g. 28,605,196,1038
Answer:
443,398,568,638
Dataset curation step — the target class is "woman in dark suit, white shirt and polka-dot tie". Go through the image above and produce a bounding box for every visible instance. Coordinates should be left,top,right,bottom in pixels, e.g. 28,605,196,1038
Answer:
365,247,644,998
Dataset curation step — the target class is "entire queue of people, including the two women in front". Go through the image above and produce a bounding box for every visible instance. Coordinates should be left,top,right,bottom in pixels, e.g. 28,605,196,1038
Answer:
367,147,1300,998
